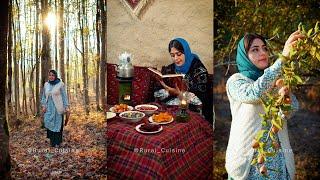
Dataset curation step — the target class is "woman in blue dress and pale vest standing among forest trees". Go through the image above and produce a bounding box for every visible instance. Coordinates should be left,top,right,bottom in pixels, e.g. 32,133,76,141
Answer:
41,70,69,147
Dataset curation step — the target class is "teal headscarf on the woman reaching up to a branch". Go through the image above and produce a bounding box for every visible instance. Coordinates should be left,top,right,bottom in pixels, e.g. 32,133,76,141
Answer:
236,37,263,81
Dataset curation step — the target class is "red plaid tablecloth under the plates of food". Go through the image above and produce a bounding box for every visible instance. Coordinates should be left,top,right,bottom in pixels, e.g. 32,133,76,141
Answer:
107,106,213,179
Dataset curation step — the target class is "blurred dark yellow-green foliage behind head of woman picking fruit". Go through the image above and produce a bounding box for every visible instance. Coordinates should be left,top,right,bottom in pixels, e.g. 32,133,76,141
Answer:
214,0,320,64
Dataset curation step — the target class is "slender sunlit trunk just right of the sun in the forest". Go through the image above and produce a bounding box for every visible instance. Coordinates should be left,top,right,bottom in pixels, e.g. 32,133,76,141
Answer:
58,0,65,81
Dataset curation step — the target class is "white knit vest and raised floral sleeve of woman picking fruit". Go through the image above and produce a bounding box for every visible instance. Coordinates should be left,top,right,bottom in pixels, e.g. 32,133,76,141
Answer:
226,60,298,179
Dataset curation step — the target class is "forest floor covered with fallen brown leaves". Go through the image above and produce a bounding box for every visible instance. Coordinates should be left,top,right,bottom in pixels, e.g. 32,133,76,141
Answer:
10,105,106,179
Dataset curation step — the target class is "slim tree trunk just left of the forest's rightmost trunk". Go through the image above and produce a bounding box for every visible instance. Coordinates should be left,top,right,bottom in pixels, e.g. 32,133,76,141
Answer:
96,2,101,111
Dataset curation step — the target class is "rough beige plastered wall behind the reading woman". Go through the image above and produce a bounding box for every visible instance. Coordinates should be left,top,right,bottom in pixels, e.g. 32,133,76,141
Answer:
107,0,213,73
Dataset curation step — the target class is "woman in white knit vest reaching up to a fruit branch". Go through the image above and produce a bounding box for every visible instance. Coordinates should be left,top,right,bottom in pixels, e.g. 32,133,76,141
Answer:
226,31,303,179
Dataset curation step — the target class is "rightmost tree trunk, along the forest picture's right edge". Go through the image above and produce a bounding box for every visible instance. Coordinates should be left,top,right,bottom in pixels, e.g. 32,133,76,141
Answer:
100,0,107,108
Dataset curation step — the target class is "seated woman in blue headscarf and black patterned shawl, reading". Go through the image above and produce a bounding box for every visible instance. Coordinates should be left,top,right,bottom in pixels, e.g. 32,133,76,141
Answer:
154,38,213,123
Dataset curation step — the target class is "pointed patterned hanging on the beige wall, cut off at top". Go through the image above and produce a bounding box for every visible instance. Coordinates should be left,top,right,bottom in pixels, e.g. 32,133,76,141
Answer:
120,0,153,19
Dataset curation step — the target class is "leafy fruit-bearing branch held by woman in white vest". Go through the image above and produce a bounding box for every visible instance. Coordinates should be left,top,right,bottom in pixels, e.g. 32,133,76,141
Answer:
251,22,320,176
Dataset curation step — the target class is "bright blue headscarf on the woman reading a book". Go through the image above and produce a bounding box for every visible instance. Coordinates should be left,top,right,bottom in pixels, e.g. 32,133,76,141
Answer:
174,38,199,74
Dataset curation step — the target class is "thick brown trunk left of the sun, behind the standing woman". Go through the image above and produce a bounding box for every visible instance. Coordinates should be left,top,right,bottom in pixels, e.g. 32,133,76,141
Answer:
41,0,51,91
